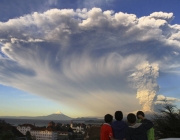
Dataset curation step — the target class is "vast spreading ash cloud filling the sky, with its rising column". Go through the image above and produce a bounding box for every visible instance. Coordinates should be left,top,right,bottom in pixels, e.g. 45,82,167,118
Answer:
0,7,180,115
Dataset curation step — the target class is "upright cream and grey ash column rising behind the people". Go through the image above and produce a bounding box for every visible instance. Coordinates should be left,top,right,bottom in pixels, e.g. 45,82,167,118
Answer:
130,62,159,112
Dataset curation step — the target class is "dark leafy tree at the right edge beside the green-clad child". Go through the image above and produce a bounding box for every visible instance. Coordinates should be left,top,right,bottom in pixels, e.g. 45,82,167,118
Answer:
153,100,180,138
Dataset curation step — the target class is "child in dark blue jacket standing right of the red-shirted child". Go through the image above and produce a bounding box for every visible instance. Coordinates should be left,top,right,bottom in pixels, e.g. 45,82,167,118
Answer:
111,111,128,140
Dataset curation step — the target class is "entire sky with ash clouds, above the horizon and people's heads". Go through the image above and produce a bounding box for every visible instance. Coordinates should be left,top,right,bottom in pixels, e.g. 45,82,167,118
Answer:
0,0,180,117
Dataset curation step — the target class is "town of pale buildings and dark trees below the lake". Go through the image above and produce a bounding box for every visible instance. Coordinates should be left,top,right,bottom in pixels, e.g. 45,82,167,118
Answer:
0,120,101,140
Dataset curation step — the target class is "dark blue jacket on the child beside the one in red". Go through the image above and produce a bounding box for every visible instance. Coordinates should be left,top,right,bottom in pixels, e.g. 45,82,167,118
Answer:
111,121,128,140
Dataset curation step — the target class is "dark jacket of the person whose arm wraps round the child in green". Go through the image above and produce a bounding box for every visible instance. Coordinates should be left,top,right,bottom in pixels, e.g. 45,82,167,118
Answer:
126,119,153,140
